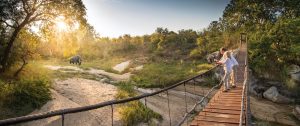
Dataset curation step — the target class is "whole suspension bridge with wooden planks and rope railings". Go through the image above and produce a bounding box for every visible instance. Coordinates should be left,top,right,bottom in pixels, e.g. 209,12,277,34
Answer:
0,34,251,126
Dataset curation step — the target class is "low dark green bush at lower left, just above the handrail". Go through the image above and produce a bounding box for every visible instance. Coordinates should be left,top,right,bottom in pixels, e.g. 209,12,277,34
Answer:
0,79,51,118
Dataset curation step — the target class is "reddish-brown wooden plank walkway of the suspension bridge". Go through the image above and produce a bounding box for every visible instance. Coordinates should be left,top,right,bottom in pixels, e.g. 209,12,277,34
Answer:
190,46,246,126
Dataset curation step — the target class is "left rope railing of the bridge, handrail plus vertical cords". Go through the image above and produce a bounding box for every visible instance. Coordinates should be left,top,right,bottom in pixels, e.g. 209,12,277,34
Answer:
0,65,221,126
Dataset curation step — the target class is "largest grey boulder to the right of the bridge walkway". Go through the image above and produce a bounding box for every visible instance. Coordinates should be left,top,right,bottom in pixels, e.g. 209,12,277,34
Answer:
263,86,294,103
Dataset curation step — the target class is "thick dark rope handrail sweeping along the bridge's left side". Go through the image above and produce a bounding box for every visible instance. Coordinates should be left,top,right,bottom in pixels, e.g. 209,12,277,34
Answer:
0,65,220,125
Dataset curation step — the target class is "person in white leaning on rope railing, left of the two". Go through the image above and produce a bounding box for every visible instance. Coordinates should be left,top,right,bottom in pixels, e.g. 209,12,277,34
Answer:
217,51,233,92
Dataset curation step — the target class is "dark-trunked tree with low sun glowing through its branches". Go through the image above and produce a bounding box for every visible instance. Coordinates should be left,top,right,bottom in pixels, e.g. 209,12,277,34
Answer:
0,0,86,72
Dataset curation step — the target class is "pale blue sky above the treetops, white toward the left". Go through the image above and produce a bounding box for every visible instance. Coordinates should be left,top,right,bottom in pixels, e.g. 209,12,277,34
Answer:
83,0,229,37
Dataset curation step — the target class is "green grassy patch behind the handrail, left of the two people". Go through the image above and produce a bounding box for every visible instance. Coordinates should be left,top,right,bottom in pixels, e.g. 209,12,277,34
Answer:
131,62,212,88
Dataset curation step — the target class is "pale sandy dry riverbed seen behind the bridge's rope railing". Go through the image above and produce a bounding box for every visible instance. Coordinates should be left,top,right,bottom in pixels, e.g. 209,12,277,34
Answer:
24,66,123,126
